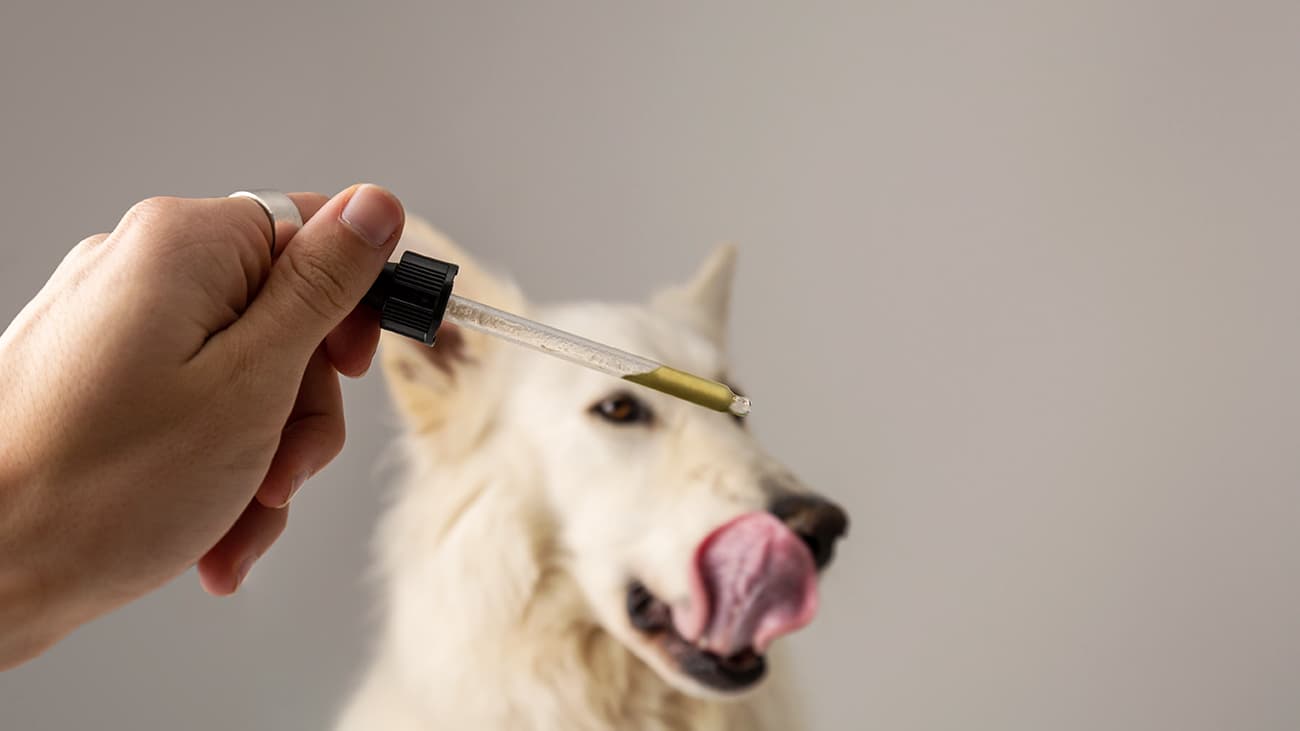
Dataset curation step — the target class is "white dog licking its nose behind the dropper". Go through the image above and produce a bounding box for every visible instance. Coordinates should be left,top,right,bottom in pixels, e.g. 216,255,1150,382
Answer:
339,217,848,731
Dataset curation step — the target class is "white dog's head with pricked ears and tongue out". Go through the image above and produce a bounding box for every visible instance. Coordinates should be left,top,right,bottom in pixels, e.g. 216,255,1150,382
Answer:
384,220,848,695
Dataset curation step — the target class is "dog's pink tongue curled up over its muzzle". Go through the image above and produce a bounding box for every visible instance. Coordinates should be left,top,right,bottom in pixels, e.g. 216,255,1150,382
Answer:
673,512,818,657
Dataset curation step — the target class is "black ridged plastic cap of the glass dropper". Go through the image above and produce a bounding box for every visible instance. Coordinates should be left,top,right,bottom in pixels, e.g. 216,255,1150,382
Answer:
361,251,460,345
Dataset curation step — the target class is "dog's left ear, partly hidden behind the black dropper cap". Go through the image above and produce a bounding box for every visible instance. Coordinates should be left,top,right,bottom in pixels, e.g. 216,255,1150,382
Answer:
380,215,527,433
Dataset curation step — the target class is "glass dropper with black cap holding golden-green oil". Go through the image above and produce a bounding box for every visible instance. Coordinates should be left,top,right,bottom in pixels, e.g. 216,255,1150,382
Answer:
365,251,750,416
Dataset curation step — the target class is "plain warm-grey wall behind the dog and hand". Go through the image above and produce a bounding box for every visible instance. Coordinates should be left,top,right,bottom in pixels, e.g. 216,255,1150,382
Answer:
0,0,1300,731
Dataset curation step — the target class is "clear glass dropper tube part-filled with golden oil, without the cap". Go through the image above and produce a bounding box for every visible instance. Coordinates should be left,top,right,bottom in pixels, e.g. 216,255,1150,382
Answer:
443,294,750,416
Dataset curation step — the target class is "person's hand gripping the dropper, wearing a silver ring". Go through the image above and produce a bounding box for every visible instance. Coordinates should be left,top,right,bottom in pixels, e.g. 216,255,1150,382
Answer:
0,186,404,669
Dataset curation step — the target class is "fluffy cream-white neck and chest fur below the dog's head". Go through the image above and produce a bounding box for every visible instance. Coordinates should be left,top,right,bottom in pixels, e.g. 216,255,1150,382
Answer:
341,429,790,731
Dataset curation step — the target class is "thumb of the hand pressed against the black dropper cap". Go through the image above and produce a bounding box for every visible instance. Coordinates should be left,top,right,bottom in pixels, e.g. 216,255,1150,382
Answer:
229,185,406,369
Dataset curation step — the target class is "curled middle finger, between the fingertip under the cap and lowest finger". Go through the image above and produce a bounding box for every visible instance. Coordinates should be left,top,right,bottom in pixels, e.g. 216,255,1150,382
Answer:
257,347,347,507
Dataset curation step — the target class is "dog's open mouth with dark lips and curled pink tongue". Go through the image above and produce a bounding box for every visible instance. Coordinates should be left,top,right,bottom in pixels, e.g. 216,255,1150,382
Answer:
627,512,818,692
